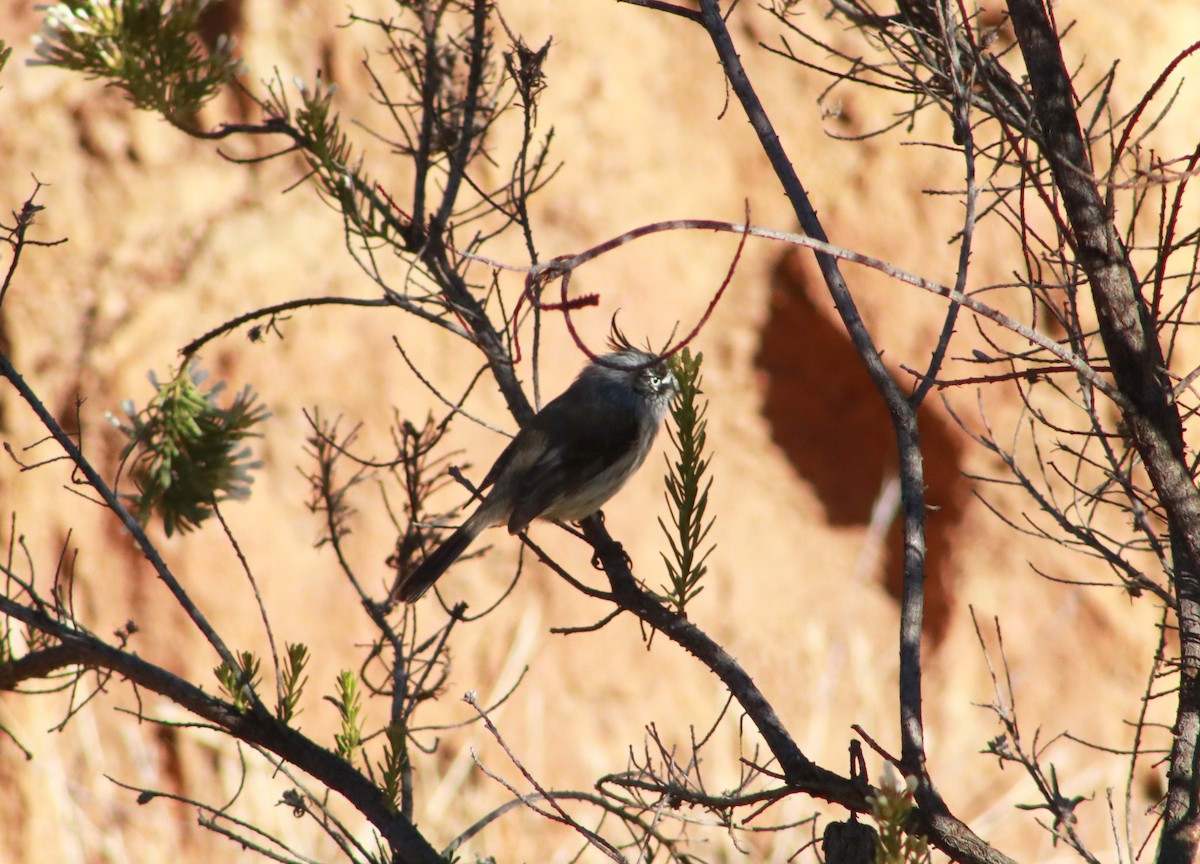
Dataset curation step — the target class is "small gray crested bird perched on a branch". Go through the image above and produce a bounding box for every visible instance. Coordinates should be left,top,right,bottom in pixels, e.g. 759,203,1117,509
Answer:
391,331,679,602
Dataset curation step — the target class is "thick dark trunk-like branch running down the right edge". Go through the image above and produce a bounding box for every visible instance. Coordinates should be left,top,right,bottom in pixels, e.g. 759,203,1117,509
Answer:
1009,6,1200,864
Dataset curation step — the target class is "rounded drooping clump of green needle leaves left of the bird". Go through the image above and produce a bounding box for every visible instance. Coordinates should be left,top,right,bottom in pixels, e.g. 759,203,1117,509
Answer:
114,365,270,536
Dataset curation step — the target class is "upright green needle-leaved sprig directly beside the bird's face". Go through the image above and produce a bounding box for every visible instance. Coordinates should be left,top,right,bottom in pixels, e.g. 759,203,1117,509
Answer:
659,348,713,616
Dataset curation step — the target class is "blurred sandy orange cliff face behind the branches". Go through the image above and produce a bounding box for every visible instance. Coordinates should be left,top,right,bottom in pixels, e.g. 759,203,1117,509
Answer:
0,0,1200,864
